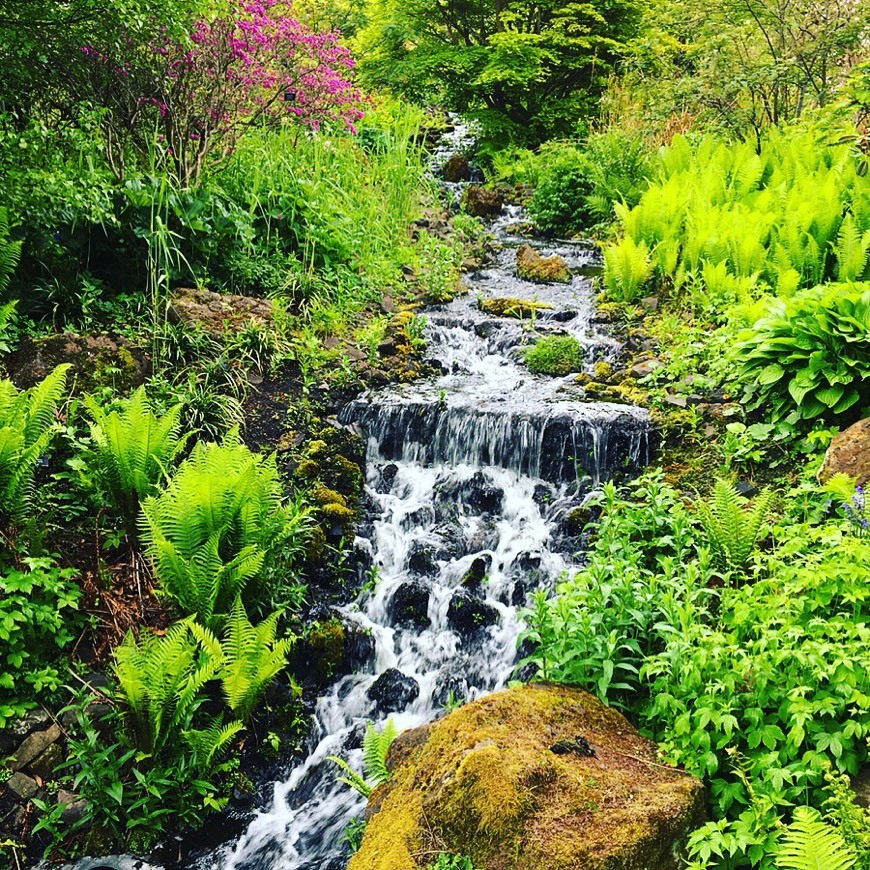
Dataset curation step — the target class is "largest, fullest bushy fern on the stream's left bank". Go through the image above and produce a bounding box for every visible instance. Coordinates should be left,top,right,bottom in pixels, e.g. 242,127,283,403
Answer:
142,432,308,627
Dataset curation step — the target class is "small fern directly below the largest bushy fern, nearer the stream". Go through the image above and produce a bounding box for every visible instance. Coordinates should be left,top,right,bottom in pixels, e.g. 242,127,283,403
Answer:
190,598,293,722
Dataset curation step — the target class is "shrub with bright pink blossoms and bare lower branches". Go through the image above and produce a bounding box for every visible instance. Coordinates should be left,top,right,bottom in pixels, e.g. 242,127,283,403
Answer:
82,0,363,185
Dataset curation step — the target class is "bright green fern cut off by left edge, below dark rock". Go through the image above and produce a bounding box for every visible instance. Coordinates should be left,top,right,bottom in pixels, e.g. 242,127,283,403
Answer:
0,365,69,523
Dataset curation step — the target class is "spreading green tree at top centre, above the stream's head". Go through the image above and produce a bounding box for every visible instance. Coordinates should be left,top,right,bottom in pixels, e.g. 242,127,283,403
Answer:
359,0,637,143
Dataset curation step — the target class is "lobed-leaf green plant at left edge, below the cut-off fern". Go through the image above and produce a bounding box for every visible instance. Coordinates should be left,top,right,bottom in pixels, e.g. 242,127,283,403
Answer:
0,558,81,728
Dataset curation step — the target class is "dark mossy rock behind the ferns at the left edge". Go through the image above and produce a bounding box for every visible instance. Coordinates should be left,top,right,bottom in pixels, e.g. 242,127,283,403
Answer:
6,332,151,392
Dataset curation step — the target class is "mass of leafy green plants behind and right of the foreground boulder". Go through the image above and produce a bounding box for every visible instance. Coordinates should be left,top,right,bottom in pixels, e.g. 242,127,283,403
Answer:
527,476,870,868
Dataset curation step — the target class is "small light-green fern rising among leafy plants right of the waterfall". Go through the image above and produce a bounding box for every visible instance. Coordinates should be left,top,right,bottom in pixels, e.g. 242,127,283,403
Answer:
697,478,773,577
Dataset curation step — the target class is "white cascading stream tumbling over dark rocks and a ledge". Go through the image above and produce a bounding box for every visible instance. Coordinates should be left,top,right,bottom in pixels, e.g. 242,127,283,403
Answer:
210,179,647,870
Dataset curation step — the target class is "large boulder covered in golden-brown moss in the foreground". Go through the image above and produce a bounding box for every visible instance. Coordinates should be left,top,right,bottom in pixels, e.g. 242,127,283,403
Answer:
348,685,704,870
